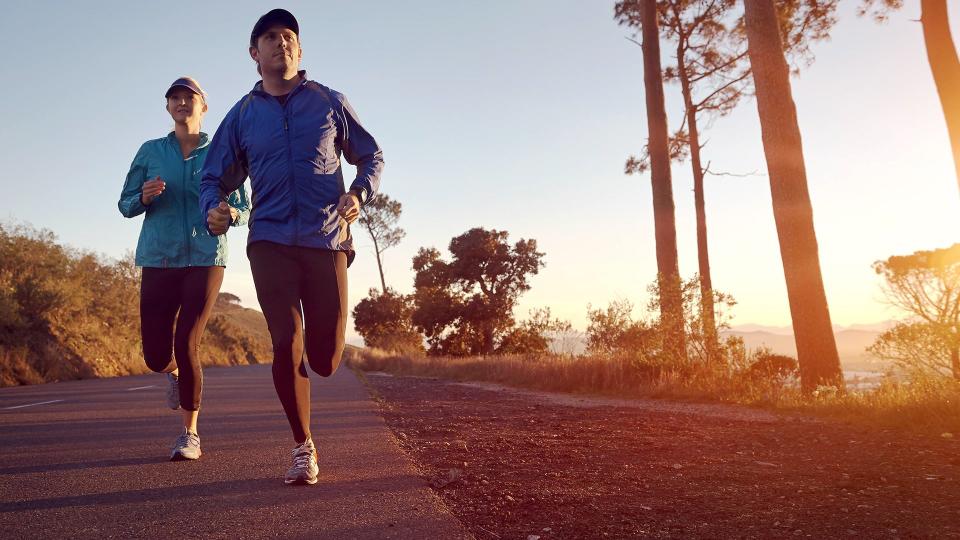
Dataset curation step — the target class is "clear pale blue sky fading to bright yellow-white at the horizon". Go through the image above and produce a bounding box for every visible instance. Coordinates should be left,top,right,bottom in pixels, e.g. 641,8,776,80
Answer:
0,0,960,339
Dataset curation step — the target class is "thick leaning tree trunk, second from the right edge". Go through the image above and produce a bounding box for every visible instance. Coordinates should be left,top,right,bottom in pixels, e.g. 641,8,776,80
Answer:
744,0,843,392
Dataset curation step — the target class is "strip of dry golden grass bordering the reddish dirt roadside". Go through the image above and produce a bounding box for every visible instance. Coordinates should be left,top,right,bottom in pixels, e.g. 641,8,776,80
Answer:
348,349,960,436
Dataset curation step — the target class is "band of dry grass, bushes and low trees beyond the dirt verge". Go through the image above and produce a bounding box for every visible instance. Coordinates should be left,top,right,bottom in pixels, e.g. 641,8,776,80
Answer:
348,224,960,436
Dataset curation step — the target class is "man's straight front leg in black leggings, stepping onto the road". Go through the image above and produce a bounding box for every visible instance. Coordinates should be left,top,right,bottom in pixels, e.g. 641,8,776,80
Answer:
247,242,310,444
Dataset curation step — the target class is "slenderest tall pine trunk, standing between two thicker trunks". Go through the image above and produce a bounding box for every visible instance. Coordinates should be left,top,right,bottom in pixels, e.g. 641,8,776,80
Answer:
677,34,719,365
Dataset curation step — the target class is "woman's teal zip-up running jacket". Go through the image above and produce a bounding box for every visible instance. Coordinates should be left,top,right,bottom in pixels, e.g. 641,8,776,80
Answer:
117,132,250,268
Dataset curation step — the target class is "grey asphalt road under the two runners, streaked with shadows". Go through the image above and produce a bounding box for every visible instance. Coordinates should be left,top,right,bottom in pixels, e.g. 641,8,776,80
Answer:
0,366,469,539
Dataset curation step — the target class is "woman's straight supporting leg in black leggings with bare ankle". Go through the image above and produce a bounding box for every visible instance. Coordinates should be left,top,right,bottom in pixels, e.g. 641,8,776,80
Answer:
174,266,223,426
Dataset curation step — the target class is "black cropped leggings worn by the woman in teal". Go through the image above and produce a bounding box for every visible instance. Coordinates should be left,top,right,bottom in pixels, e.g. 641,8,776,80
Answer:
140,266,223,411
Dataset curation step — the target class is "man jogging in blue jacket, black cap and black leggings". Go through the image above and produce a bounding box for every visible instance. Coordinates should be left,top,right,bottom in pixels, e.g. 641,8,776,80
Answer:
200,9,383,484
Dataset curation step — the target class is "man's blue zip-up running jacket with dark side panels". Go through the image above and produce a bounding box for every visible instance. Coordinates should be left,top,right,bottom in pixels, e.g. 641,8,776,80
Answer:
200,71,383,261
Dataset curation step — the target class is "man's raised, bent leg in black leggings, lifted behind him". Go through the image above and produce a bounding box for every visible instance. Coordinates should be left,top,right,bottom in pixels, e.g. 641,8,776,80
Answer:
299,248,347,377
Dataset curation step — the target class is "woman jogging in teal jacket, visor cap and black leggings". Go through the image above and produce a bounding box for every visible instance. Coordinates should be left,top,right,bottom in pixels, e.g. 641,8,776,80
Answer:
118,77,250,460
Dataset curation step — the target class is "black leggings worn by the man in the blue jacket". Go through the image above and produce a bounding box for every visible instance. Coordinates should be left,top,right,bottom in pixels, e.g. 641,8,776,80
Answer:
247,241,347,444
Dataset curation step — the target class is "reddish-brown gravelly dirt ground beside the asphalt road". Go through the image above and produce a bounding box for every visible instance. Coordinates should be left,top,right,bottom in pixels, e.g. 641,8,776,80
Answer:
366,373,960,540
